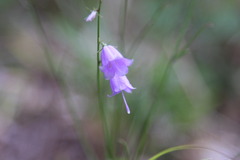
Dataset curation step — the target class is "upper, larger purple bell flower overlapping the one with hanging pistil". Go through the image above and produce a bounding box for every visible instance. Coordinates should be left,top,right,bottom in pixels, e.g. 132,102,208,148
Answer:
100,45,133,80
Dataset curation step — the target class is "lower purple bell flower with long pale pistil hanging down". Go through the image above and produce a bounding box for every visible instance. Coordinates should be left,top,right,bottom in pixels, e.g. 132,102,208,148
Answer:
110,75,136,114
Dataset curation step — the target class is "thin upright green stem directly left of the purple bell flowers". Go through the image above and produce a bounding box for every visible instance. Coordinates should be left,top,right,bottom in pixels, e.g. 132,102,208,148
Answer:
97,0,114,159
